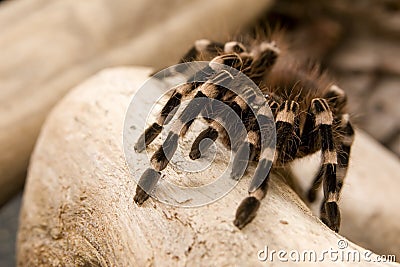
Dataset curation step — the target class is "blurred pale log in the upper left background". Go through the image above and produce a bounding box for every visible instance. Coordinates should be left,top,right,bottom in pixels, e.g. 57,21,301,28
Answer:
0,0,271,205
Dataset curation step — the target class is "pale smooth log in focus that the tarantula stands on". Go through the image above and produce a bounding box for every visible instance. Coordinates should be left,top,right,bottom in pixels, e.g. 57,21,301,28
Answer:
17,68,400,266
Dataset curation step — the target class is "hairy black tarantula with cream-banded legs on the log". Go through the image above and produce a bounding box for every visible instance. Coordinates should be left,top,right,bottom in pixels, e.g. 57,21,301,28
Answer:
134,35,354,232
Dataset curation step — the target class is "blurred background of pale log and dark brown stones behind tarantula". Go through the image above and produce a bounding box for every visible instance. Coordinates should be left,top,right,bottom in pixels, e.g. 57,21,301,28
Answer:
0,0,400,266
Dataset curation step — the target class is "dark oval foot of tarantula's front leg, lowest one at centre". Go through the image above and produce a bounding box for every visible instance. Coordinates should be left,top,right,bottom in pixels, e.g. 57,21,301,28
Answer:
233,197,260,229
